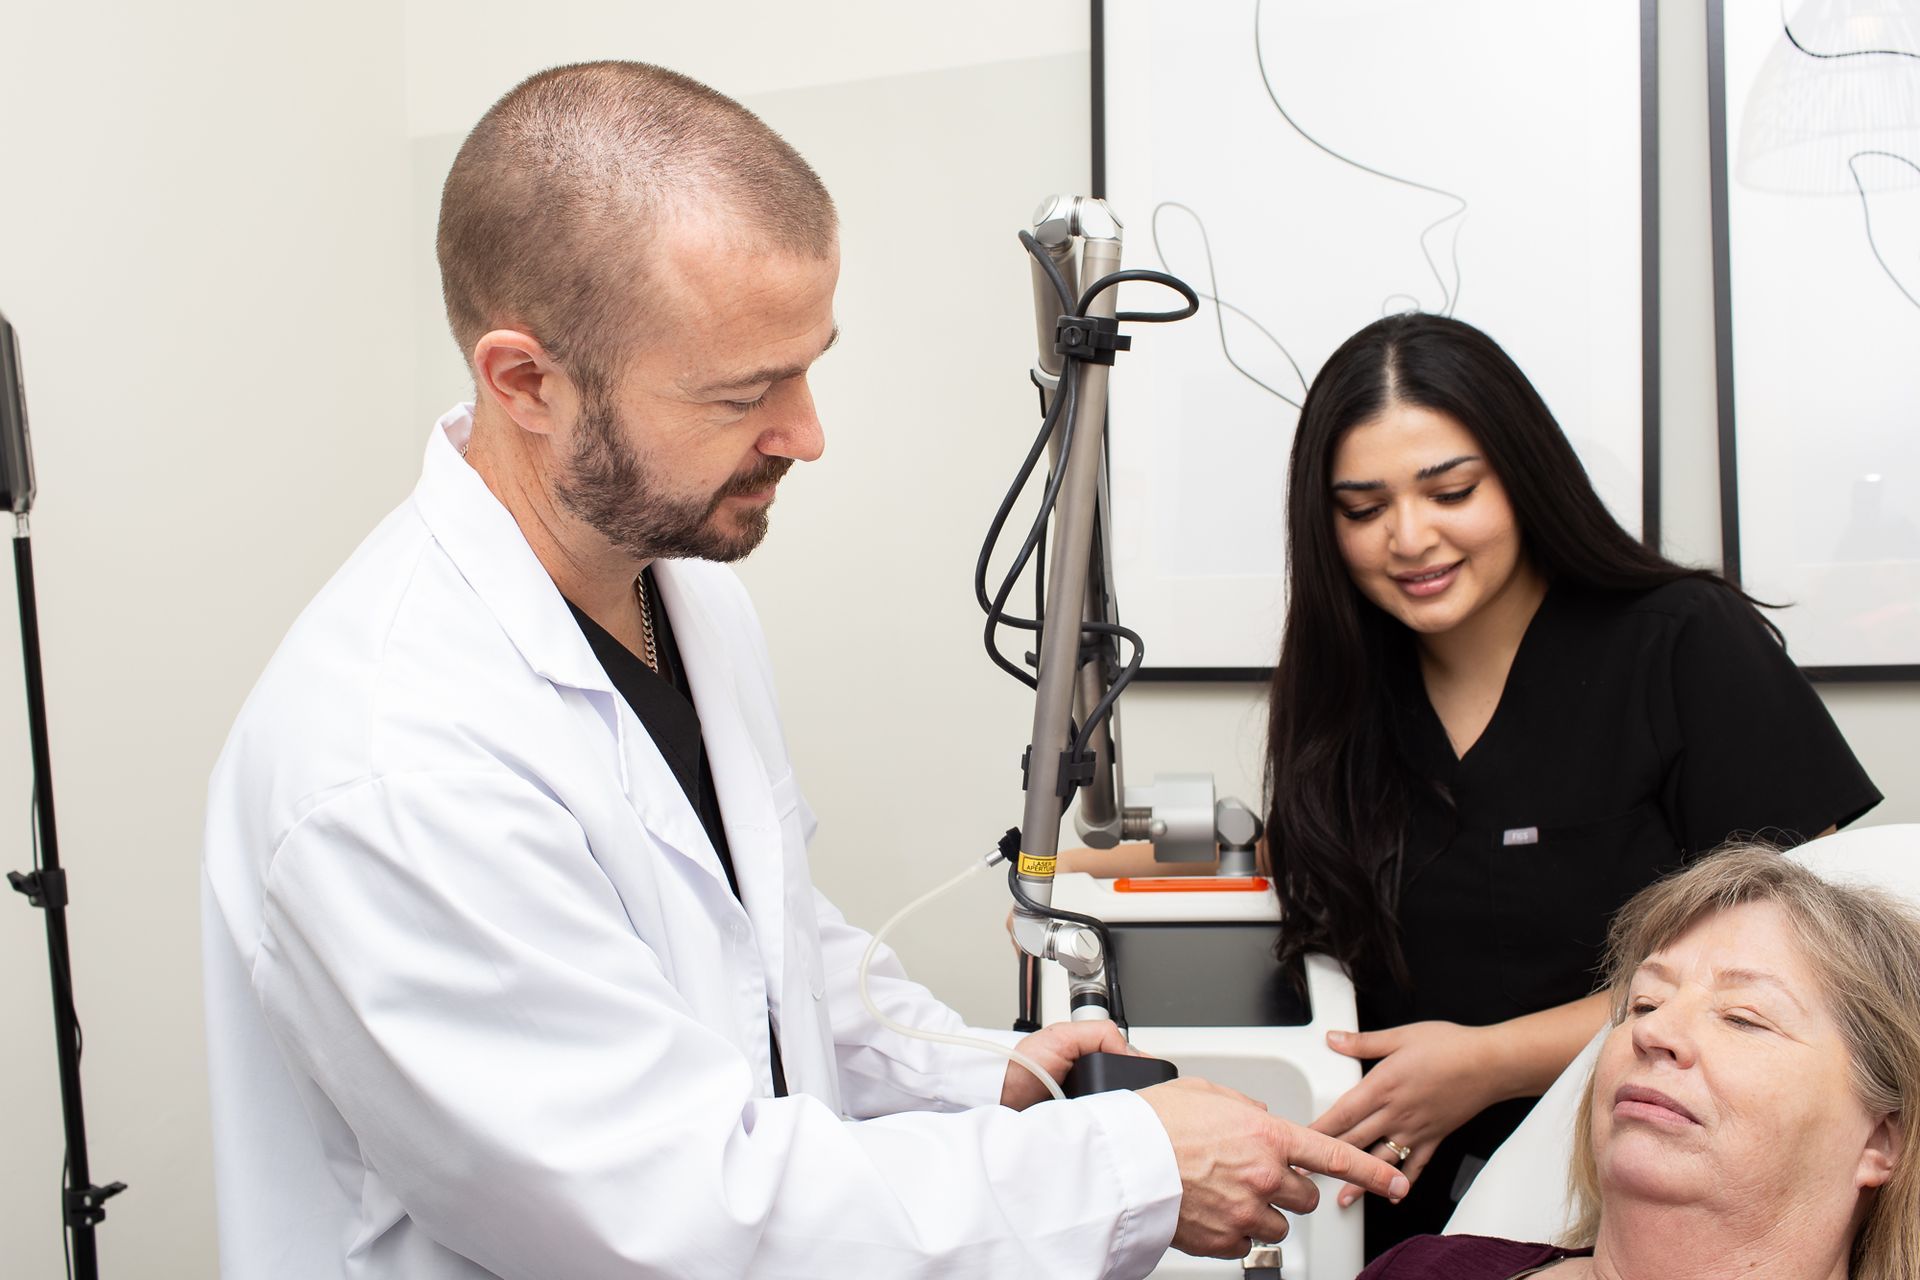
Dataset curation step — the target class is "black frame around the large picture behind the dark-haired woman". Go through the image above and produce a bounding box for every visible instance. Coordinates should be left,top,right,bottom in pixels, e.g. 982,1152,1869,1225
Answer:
1089,0,1666,685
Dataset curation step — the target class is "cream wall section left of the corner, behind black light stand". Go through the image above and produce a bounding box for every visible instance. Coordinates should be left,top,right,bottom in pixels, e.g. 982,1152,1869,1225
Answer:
0,0,424,1278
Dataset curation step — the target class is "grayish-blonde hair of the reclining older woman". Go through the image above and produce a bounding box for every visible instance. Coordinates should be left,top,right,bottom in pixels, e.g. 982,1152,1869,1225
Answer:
1569,842,1920,1280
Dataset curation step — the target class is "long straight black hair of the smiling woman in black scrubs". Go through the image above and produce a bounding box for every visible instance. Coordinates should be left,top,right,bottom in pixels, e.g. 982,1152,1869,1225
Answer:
1265,315,1780,984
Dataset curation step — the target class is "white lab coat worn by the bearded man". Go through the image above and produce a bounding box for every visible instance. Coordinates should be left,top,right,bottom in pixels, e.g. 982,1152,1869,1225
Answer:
204,409,1181,1280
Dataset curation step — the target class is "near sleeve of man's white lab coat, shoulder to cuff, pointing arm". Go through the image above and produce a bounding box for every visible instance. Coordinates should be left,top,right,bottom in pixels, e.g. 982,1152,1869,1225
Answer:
250,771,1179,1280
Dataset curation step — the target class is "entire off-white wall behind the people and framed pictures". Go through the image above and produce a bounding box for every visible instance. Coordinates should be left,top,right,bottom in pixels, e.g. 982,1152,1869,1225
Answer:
0,0,1920,1278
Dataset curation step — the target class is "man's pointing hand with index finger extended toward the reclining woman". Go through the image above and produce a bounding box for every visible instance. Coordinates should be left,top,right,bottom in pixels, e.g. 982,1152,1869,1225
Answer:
1140,1079,1409,1257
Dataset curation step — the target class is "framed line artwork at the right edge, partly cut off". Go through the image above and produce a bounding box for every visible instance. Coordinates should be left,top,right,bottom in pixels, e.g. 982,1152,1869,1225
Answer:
1707,0,1920,679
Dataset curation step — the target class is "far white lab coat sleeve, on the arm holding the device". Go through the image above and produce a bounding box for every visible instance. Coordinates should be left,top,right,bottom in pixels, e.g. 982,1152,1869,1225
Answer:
814,889,1021,1117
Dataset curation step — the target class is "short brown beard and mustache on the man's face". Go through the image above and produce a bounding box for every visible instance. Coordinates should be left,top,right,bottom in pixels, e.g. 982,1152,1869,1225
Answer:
555,395,793,562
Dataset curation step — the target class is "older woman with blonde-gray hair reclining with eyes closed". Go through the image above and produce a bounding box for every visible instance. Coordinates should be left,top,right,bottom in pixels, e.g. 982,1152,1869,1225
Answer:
1361,846,1920,1280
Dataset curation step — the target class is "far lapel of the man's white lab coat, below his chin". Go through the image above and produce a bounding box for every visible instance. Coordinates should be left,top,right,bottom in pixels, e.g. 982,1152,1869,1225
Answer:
653,560,785,1002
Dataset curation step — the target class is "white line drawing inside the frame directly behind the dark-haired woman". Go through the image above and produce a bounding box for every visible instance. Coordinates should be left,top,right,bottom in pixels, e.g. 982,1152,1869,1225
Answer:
1096,0,1643,677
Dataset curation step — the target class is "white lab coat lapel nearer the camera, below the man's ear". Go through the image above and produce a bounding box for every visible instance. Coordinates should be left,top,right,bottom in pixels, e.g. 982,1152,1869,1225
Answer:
413,405,733,898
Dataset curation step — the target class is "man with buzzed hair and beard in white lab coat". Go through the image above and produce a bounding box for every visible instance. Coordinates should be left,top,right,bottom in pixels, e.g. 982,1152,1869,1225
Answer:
204,63,1405,1280
